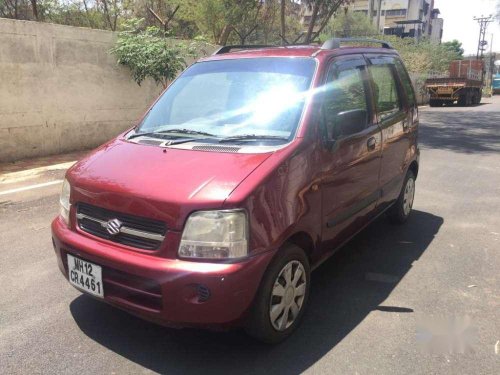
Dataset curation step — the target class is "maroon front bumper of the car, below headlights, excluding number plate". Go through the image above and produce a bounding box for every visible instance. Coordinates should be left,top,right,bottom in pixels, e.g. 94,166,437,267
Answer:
52,218,274,327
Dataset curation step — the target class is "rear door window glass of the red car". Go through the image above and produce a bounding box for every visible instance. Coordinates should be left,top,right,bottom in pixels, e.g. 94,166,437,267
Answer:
369,64,402,120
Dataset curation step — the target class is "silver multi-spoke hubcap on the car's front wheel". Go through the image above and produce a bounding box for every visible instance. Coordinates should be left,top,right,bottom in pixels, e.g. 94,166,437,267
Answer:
269,260,307,331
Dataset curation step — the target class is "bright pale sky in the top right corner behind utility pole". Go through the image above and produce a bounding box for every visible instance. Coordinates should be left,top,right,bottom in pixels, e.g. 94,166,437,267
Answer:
434,0,500,55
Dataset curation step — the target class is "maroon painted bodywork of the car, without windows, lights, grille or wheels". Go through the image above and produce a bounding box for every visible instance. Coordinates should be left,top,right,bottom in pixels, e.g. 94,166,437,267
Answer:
52,47,418,326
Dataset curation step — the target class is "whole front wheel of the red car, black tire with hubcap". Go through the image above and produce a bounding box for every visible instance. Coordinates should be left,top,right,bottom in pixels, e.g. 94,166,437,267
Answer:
245,244,311,344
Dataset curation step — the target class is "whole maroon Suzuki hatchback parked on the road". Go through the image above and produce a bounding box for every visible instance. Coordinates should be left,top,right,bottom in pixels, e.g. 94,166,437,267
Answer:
52,39,419,342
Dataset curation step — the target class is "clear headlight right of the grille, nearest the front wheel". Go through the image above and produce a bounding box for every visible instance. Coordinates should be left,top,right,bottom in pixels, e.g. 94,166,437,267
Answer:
179,210,248,259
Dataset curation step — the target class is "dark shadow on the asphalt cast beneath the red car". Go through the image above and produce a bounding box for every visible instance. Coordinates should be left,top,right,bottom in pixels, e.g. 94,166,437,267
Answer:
70,211,443,374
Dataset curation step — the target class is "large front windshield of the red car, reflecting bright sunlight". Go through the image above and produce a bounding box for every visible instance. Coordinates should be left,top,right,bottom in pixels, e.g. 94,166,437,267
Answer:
136,57,316,142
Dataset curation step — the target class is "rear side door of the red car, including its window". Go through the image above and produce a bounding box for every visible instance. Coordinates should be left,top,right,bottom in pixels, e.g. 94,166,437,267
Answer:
367,55,413,208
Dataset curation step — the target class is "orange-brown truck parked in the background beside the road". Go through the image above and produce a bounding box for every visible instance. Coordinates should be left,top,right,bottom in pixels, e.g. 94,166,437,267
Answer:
425,60,484,107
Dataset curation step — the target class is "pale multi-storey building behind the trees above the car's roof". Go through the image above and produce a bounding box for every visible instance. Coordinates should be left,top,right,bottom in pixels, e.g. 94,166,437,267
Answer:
350,0,443,43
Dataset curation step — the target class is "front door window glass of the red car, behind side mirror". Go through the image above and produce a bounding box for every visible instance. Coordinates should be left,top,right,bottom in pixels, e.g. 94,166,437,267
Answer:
323,60,368,139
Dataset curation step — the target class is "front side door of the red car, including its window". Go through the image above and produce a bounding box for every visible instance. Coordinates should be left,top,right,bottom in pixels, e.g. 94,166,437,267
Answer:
321,55,381,250
